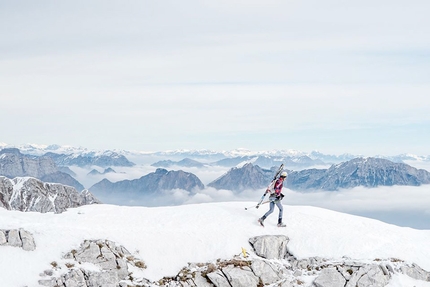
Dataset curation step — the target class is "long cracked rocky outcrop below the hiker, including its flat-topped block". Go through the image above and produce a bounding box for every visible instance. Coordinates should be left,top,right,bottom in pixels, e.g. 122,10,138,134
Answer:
159,235,430,287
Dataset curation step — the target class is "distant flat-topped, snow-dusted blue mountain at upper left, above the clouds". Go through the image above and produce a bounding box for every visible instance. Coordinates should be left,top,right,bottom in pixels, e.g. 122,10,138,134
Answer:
44,151,135,167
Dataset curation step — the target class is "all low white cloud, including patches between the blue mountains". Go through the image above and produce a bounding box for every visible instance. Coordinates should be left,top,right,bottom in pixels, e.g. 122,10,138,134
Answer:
83,163,430,229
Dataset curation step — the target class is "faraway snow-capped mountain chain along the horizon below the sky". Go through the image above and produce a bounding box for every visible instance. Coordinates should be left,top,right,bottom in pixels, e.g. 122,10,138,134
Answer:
0,143,430,168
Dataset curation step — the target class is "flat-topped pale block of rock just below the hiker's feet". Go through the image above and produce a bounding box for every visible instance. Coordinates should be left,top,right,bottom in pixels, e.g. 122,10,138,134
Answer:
249,235,289,259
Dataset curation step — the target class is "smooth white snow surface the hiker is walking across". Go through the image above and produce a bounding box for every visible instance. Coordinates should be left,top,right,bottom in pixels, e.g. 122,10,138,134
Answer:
0,202,430,287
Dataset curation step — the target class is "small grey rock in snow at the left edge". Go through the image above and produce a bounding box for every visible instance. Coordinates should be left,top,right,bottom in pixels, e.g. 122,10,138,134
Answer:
0,228,36,251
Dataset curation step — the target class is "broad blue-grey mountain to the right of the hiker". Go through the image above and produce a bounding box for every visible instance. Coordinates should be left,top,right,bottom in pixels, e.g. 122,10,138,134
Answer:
286,157,430,191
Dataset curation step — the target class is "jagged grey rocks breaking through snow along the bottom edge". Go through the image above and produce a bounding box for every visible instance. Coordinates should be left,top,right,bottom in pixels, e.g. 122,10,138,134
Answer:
39,235,430,287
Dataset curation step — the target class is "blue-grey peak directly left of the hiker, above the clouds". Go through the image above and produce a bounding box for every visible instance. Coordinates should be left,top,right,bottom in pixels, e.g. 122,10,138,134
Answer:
208,163,276,191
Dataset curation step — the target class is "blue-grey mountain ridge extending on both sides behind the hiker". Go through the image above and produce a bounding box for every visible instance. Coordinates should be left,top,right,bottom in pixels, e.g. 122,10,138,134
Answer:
208,158,430,194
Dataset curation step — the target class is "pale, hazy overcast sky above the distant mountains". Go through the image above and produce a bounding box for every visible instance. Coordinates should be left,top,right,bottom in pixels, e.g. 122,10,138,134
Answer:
0,0,430,156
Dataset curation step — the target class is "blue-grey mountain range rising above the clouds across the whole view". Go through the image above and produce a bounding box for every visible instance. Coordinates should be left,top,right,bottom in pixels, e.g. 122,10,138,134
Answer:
0,145,430,195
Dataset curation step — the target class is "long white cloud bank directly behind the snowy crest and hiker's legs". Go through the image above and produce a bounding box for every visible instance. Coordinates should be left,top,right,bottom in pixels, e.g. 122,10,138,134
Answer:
101,186,430,232
